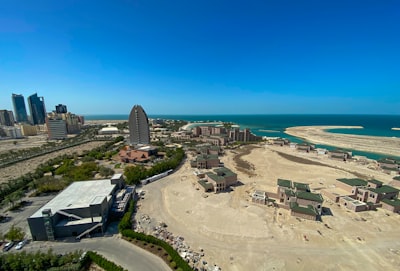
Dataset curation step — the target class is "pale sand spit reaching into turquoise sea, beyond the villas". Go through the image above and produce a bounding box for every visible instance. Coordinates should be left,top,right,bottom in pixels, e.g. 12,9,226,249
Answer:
285,126,400,156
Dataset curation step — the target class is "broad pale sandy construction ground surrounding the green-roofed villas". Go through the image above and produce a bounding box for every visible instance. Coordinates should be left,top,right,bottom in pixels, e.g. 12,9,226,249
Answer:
138,146,400,270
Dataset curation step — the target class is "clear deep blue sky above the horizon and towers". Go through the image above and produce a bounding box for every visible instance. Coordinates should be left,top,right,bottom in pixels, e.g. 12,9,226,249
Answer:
0,0,400,114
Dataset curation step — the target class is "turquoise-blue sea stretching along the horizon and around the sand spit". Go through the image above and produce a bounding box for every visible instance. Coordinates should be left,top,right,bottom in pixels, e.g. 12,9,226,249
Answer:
85,114,400,162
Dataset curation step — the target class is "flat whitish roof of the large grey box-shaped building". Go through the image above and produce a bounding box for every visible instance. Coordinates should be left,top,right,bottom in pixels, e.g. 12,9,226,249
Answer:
31,179,115,218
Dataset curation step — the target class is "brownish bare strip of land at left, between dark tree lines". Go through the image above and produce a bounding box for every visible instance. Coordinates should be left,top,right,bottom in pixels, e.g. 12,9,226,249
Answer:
0,141,108,183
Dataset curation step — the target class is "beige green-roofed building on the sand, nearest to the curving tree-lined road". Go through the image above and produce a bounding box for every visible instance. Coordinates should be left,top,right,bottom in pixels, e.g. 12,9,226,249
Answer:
197,167,237,193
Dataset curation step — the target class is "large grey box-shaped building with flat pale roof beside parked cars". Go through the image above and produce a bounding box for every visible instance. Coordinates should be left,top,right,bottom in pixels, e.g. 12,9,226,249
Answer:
28,175,123,241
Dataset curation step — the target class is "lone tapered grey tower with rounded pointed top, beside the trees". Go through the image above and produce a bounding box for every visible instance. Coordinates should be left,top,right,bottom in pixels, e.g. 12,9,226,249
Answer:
129,105,150,145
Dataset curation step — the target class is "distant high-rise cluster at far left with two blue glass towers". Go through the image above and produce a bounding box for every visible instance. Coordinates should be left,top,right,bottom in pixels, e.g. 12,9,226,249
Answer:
0,93,84,139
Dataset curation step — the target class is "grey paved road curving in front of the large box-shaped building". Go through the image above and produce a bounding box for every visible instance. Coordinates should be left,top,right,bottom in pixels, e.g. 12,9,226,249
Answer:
6,235,171,271
